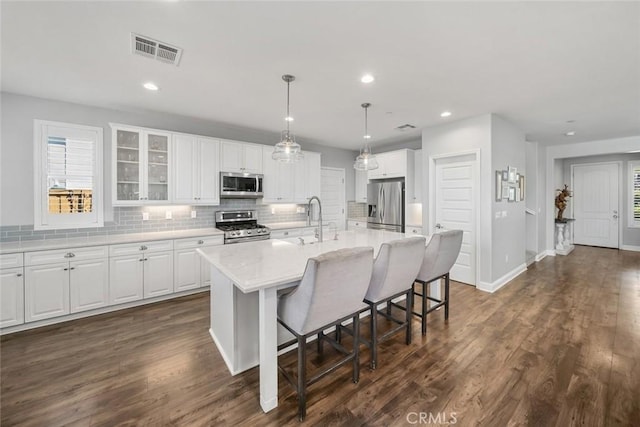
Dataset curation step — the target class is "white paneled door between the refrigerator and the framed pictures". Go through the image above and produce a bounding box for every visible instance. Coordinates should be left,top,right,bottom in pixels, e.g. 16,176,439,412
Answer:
431,157,477,286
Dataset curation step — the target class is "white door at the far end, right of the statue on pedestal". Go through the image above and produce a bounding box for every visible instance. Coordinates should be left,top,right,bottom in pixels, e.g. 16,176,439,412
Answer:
572,163,620,248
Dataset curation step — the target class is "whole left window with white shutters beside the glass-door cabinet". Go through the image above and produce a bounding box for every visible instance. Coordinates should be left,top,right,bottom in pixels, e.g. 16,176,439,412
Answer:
34,120,103,229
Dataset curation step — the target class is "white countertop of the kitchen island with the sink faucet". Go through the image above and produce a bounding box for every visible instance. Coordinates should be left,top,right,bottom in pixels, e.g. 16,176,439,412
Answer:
198,229,429,293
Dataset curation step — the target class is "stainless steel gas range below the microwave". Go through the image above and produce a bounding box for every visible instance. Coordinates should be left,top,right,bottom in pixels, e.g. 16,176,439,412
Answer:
216,211,271,245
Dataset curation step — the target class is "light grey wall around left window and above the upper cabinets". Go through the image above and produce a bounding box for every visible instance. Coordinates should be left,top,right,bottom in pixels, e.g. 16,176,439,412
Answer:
0,92,356,225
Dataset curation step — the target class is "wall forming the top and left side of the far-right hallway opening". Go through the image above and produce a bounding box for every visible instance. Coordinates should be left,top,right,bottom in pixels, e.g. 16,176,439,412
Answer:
544,135,640,253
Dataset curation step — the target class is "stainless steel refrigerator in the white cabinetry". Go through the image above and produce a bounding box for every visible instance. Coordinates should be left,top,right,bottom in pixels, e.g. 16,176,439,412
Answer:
367,179,404,233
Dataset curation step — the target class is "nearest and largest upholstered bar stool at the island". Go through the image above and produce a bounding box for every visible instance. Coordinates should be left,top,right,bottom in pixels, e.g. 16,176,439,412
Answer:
278,247,373,421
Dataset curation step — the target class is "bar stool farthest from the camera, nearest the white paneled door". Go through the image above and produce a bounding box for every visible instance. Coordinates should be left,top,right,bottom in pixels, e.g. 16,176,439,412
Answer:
407,230,463,335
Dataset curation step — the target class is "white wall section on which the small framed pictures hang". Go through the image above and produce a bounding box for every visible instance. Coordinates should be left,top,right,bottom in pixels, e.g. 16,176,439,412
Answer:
489,115,527,283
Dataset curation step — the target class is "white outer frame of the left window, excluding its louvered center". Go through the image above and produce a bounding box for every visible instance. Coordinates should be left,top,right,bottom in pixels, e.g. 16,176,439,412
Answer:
33,119,104,230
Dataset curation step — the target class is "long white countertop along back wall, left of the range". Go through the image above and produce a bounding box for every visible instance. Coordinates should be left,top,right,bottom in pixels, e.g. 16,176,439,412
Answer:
0,228,224,254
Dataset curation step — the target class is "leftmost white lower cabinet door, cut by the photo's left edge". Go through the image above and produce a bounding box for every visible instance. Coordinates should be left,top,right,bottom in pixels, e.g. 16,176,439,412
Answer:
0,268,24,328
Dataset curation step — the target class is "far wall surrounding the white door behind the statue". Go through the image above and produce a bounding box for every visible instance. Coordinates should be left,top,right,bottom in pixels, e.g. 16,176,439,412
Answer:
562,153,640,248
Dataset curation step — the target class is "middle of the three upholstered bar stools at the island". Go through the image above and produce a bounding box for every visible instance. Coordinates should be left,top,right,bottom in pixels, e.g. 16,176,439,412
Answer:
354,237,426,369
